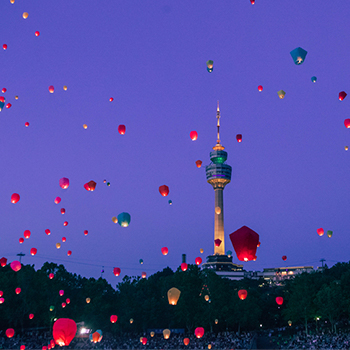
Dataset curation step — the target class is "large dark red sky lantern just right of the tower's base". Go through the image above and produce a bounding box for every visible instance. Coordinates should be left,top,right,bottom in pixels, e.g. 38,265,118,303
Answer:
230,226,259,261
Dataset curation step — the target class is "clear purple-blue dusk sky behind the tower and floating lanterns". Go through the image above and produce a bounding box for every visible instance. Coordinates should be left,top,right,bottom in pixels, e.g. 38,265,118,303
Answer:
0,0,350,285
